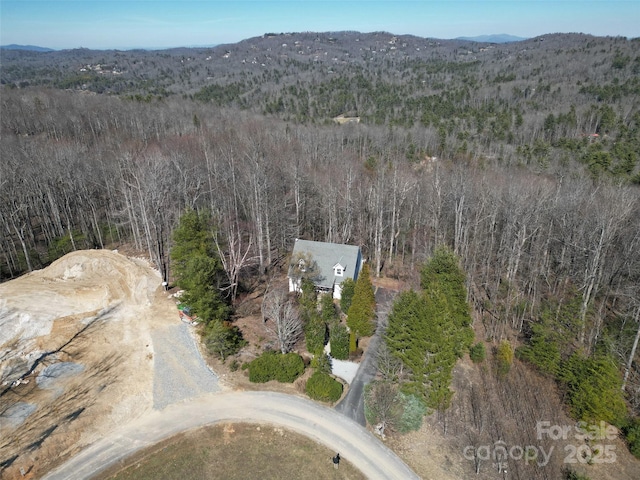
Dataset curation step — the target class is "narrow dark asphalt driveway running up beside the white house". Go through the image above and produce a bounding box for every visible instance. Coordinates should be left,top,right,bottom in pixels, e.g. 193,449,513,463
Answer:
336,288,394,426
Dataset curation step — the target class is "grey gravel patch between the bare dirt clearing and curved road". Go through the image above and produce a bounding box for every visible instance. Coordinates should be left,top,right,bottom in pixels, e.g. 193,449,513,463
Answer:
151,323,220,409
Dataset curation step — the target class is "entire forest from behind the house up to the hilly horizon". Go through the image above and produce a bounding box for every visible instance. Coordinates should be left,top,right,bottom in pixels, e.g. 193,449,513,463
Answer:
0,32,640,466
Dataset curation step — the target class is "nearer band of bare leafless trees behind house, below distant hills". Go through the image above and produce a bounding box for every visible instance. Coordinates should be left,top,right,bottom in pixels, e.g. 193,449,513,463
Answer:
0,85,640,409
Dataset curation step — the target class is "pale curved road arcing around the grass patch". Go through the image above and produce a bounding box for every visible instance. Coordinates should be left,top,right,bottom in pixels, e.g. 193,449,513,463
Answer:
44,392,419,480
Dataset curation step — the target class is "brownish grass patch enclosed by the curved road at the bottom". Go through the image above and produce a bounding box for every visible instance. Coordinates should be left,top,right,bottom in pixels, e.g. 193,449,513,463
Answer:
97,423,365,480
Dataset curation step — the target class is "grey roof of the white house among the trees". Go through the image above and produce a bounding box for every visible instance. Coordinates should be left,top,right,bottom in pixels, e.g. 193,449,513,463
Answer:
289,239,360,288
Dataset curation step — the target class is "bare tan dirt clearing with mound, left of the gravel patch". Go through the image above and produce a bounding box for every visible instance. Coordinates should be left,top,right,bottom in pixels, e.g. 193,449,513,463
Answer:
0,250,180,479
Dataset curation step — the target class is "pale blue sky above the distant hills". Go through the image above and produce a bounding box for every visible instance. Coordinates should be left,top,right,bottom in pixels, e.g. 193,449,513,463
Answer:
0,0,640,49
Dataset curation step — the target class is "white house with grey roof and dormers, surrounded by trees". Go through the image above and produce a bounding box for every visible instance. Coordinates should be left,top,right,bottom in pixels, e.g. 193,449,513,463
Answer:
288,239,362,299
